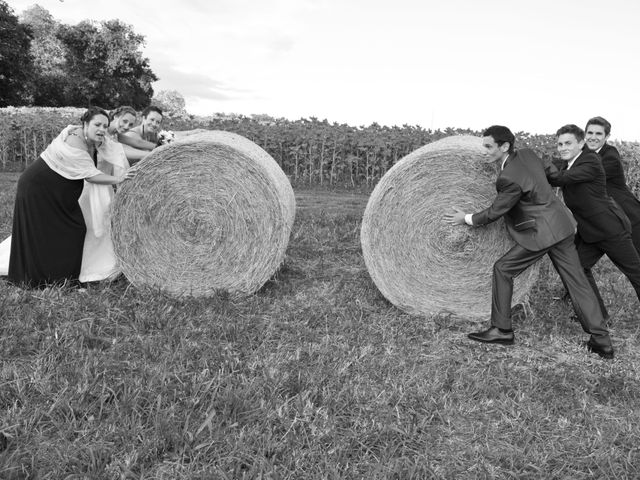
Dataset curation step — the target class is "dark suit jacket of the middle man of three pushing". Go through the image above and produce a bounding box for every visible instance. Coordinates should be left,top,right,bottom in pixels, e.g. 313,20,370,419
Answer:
546,150,631,243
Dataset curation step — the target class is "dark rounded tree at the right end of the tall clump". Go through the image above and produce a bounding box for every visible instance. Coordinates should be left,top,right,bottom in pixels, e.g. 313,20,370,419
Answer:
57,20,158,109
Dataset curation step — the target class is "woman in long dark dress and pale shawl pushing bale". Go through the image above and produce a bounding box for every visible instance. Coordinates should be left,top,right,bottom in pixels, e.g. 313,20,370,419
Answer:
8,107,134,288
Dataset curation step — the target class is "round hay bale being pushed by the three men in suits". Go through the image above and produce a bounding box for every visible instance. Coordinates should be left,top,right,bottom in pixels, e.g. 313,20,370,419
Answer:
360,135,538,319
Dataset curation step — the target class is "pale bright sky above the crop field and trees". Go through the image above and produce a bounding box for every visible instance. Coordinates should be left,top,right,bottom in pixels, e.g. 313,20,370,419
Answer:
7,0,640,141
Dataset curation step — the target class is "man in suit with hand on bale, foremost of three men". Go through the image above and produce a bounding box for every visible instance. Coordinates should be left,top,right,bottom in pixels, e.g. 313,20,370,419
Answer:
444,125,613,358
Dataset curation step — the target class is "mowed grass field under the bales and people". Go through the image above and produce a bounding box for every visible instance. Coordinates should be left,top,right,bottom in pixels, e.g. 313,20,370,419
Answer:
0,174,640,479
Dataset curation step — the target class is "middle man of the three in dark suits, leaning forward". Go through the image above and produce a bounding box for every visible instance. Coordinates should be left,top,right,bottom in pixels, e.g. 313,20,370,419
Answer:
546,125,640,316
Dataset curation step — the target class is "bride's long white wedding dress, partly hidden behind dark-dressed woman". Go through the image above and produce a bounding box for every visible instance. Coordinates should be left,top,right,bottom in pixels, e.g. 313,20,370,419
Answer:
0,138,129,283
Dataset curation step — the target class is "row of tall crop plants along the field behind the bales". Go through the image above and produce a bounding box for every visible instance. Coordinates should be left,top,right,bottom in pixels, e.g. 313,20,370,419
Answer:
0,107,640,193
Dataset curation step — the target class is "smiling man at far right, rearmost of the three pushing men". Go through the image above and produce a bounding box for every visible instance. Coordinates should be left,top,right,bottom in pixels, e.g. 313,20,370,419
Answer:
585,117,640,253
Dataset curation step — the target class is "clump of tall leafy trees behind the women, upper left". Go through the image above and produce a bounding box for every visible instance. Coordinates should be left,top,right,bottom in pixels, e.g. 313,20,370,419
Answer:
0,0,158,109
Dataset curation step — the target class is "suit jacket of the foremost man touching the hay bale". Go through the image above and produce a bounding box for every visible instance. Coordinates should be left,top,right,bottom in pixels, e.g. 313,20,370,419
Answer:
472,149,576,252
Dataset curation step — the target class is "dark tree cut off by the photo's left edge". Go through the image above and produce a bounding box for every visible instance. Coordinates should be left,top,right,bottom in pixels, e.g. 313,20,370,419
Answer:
0,0,33,107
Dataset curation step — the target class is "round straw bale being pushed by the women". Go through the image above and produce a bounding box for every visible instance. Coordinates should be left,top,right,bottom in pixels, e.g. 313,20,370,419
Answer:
112,131,295,296
